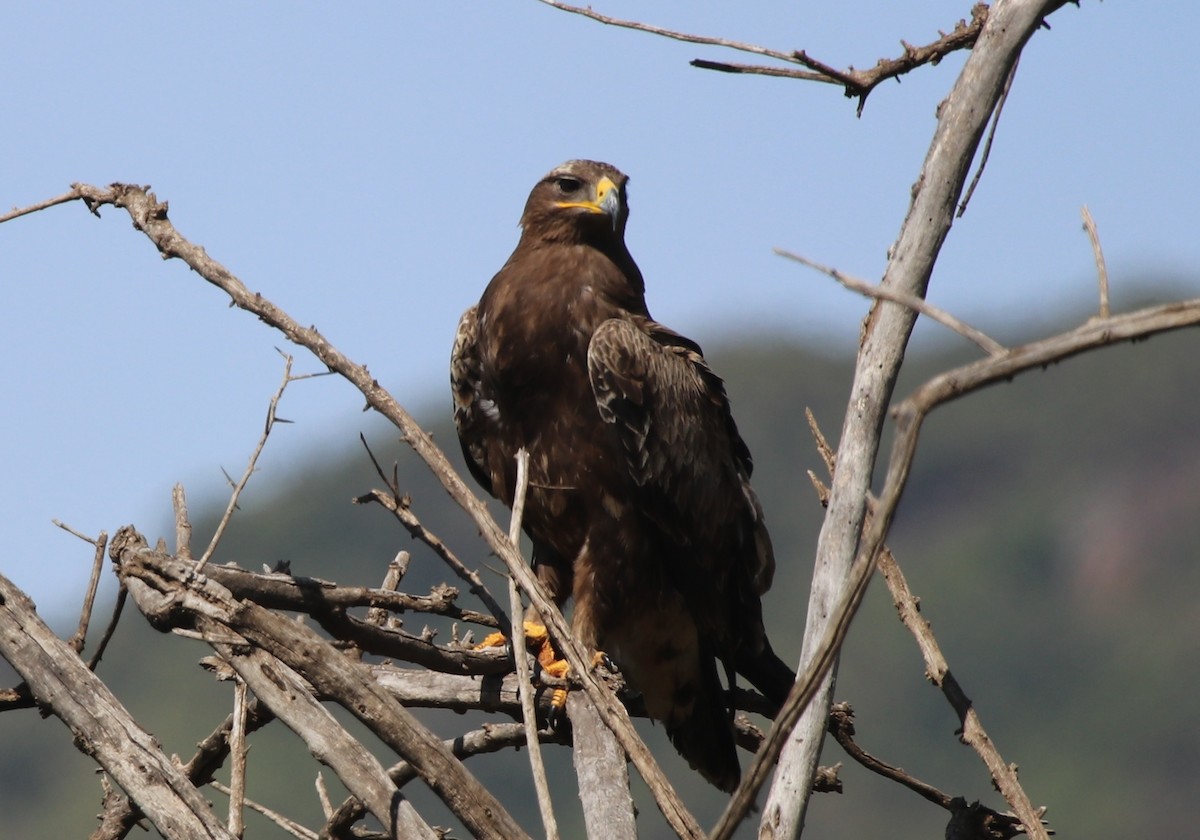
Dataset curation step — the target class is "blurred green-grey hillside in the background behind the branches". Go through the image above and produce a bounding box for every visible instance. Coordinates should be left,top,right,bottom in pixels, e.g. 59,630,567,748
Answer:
0,316,1200,840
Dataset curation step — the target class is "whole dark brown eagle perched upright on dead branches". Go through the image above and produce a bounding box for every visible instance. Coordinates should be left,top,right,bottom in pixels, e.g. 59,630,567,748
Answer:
450,161,794,791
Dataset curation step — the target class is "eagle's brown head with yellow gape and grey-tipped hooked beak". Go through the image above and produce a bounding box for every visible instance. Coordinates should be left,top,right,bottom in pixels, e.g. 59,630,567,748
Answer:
521,161,629,245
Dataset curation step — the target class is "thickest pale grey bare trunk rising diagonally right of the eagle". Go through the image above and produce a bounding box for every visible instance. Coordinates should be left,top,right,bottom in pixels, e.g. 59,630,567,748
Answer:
713,0,1080,840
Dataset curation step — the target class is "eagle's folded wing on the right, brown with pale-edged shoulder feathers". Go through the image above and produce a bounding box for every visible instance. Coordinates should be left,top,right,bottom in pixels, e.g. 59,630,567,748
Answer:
588,319,775,600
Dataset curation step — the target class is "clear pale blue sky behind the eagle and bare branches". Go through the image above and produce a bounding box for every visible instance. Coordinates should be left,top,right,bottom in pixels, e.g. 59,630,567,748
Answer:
0,0,1200,612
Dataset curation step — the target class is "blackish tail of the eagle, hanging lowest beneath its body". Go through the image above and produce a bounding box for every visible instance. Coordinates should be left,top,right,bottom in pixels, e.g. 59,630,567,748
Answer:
664,658,742,793
